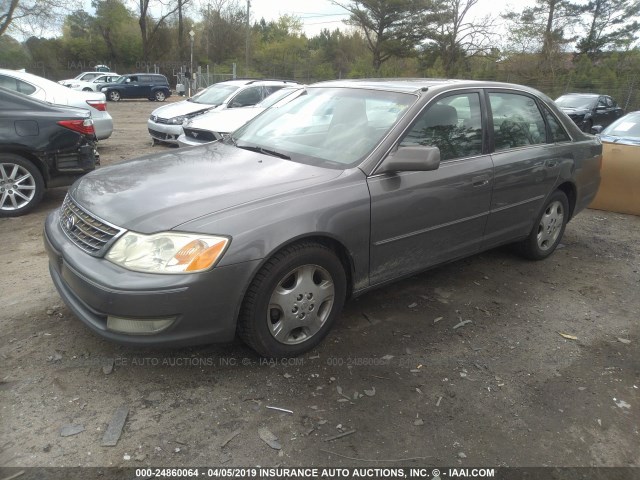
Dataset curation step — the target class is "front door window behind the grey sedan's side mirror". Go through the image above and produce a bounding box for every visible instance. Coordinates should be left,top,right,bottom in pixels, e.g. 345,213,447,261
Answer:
401,93,482,161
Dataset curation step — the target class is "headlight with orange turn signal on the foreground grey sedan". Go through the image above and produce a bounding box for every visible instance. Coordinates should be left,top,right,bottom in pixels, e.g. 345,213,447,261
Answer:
106,232,230,273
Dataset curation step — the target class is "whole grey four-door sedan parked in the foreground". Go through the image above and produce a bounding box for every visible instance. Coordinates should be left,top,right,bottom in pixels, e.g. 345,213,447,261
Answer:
45,79,602,356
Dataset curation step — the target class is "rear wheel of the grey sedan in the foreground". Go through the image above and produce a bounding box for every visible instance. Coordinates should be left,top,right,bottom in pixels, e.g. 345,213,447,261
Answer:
520,190,569,260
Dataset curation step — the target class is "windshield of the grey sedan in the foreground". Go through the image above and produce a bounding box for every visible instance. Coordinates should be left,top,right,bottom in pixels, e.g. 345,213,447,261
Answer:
229,87,417,168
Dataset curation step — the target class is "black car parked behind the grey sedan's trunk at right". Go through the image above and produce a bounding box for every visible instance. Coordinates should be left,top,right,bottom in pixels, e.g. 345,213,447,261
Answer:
556,93,624,133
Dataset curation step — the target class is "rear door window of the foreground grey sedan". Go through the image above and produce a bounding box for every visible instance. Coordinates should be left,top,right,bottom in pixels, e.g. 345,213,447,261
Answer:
489,92,546,152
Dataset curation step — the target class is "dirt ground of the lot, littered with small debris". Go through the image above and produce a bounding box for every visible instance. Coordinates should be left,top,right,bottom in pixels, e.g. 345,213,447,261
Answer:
0,99,640,467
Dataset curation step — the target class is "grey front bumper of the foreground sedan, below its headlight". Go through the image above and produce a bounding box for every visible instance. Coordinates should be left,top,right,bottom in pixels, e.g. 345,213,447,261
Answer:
44,210,259,347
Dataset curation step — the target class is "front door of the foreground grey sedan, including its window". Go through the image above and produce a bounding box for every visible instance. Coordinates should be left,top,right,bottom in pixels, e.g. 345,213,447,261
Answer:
367,90,493,285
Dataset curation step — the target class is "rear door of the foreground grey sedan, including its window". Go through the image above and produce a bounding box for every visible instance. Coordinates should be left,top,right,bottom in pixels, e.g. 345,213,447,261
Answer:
483,90,572,249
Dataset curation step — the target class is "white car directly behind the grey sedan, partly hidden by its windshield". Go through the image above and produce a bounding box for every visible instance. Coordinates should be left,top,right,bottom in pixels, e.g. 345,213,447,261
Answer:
178,86,304,147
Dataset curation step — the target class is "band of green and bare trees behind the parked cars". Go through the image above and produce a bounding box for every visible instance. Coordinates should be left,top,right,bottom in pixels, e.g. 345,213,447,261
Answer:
0,0,640,108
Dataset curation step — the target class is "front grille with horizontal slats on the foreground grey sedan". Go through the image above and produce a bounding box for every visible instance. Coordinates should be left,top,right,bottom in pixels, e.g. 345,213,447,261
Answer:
60,195,124,257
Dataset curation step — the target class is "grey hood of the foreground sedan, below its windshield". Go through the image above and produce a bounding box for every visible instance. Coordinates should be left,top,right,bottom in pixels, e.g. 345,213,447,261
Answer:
69,143,342,233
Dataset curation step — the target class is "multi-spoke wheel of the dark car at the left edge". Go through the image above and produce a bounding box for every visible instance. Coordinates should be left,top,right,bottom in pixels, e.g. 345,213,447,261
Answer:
0,153,45,217
